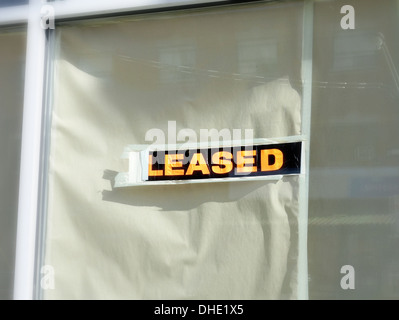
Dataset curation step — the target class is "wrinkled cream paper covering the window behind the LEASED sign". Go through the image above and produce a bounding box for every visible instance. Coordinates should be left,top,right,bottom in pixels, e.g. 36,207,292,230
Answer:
44,5,302,299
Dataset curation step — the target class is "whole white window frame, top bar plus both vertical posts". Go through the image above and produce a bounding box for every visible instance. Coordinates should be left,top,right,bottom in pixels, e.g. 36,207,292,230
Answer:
0,0,314,300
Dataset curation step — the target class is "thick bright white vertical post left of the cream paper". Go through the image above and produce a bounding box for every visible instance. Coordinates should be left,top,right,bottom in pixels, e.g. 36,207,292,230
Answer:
14,0,46,300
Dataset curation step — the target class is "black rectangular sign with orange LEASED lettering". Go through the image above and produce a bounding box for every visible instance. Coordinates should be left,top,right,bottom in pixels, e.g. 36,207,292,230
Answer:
148,142,302,181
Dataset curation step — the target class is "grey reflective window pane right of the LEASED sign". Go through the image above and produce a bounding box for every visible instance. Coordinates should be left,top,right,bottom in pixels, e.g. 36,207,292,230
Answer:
308,0,399,299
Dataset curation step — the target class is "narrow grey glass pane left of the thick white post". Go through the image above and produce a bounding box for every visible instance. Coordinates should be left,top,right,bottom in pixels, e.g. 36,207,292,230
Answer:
0,29,26,299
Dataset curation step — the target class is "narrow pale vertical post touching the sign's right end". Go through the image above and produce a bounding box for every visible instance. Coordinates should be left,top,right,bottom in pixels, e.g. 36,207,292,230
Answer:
298,0,314,300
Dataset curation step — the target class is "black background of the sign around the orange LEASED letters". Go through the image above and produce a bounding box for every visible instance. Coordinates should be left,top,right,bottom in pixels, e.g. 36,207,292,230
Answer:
147,142,302,181
